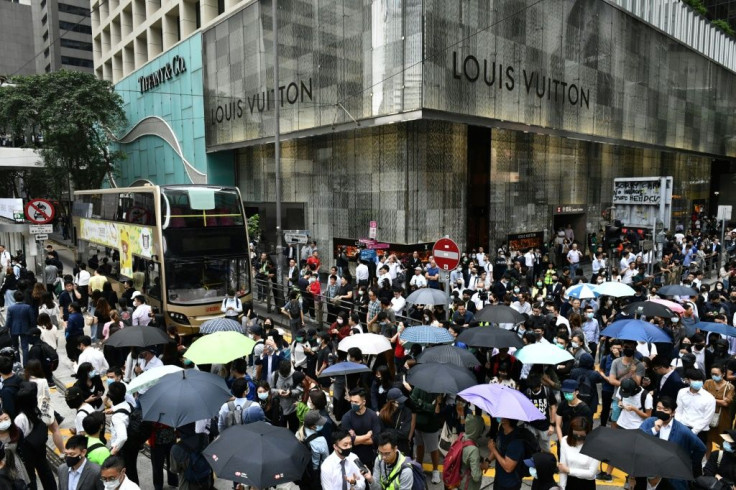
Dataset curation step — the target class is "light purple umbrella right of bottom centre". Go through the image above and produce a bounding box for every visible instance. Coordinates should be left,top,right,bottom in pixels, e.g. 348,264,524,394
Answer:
457,384,544,422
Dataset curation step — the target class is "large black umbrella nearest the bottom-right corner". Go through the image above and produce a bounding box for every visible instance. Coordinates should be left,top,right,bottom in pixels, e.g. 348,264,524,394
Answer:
580,427,693,480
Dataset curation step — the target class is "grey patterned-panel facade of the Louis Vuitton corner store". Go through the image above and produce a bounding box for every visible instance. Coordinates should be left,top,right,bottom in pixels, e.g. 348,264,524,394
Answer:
106,0,736,258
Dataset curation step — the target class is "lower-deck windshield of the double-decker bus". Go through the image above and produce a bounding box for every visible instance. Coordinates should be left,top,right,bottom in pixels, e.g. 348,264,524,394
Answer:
166,256,249,305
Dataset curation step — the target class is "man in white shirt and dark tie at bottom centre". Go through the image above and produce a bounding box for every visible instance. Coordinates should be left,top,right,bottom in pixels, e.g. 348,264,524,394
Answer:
320,430,368,490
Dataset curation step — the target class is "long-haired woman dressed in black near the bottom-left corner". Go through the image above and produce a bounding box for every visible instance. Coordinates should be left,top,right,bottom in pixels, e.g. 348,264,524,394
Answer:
14,383,57,490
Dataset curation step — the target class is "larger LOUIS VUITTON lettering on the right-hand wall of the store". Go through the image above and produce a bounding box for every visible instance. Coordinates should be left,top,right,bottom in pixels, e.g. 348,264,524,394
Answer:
452,51,590,109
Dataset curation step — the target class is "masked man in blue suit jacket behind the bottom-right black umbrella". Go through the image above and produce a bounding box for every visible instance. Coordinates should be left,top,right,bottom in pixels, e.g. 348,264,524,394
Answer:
639,396,705,490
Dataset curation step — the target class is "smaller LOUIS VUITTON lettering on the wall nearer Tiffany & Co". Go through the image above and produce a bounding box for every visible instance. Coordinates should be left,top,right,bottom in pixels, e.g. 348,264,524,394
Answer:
210,78,312,124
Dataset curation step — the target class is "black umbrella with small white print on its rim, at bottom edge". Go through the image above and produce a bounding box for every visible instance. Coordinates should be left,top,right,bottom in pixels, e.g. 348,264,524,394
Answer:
202,422,312,488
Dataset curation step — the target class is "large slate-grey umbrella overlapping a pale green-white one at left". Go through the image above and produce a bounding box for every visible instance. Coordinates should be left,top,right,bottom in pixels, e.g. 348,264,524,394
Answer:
140,369,231,427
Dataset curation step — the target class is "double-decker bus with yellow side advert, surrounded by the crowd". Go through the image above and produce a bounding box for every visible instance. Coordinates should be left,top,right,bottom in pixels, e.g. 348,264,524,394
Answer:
72,183,252,334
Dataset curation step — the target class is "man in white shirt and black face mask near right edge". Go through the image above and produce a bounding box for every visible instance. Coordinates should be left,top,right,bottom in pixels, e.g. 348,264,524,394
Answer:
675,369,716,443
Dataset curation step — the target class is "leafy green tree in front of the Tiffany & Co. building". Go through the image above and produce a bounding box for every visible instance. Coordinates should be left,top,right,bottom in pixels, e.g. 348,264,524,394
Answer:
0,70,126,193
